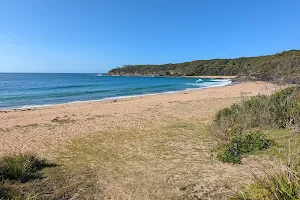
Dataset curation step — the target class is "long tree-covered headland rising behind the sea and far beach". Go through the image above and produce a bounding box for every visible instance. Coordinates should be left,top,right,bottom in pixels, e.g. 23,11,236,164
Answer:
108,50,300,83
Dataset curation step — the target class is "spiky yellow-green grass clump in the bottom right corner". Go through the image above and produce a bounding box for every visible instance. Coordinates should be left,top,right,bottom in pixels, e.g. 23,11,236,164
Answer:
232,139,300,200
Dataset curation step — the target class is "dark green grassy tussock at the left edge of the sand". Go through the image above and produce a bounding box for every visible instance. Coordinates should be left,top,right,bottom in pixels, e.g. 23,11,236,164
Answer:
0,154,50,181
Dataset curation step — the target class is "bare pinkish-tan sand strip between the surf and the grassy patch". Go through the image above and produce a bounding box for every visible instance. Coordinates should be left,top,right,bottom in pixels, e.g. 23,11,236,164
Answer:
0,82,279,156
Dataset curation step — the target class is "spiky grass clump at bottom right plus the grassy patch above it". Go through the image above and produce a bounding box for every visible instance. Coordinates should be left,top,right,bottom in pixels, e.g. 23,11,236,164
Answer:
232,130,300,200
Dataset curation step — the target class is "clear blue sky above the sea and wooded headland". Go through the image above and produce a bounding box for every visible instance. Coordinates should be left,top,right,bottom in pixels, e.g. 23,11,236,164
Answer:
0,0,300,73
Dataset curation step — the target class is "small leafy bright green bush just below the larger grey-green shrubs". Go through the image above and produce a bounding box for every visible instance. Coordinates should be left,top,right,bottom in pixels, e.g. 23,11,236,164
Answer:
217,131,270,164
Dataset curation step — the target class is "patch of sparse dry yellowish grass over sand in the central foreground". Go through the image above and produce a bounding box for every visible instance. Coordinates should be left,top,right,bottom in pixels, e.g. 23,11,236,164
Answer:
58,119,264,199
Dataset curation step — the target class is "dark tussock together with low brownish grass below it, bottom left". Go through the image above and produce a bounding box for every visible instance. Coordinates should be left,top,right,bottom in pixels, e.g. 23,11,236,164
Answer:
0,154,95,200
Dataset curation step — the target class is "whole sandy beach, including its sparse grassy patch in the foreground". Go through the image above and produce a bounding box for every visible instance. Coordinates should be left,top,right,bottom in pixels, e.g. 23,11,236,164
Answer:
0,82,286,199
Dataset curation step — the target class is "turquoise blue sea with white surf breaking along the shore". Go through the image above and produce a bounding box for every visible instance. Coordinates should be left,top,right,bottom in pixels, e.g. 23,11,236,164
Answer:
0,73,231,110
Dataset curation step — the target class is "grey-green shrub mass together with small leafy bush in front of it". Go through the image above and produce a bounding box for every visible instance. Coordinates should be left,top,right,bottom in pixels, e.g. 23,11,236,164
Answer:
213,87,300,163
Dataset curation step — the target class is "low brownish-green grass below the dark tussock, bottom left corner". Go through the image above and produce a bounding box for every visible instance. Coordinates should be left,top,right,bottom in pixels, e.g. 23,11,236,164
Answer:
0,166,97,200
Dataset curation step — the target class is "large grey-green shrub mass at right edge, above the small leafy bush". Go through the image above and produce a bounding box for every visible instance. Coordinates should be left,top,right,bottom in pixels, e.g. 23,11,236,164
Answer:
213,87,300,141
